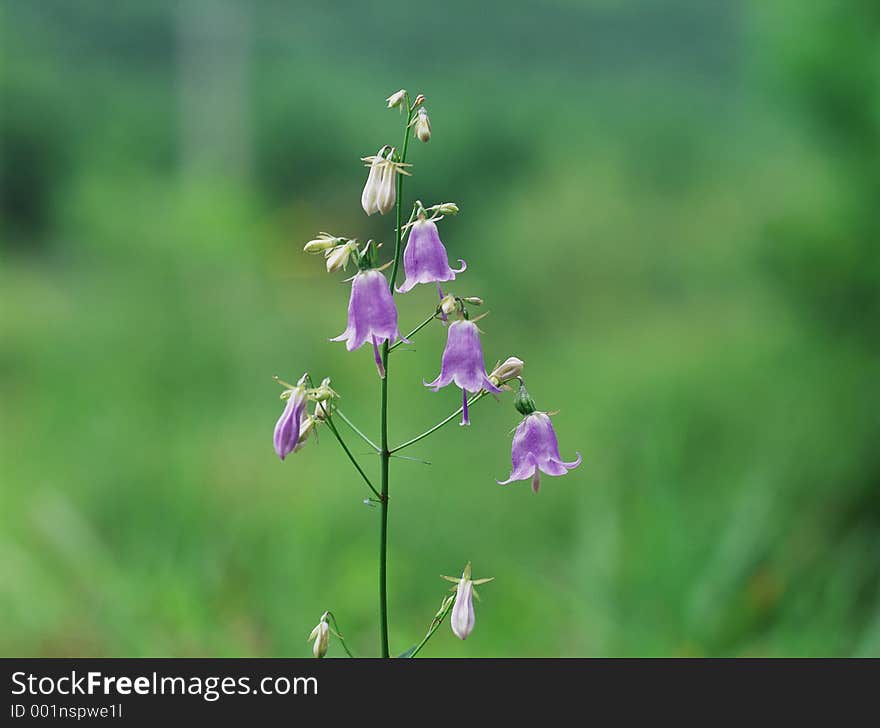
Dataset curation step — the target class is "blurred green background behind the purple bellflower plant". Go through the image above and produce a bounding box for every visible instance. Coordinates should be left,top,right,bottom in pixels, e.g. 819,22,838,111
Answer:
0,0,880,656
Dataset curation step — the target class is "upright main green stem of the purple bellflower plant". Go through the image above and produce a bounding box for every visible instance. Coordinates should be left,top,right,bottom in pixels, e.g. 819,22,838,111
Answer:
379,95,413,657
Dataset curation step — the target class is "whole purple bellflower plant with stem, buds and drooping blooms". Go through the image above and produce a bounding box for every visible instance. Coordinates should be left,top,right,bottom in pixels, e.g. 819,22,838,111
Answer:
273,89,581,657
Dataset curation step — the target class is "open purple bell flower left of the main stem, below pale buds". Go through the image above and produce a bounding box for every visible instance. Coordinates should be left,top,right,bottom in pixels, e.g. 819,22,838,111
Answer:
330,269,405,377
